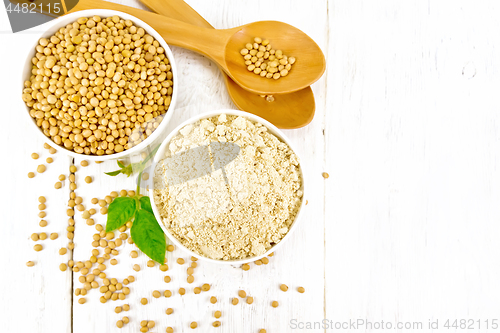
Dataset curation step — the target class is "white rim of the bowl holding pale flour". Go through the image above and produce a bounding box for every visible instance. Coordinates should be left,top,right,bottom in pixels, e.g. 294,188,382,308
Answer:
149,109,307,265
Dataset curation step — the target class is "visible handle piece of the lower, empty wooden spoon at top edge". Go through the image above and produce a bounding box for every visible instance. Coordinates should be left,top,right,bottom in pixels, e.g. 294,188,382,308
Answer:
140,0,214,29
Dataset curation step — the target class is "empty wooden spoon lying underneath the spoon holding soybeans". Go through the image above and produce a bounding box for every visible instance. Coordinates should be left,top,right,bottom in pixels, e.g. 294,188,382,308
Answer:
137,0,315,129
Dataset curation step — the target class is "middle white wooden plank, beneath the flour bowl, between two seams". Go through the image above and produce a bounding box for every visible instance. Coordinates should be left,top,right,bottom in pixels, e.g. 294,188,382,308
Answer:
66,1,326,333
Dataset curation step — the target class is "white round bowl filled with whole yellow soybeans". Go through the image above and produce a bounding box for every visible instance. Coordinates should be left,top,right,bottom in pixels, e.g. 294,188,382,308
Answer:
20,9,178,161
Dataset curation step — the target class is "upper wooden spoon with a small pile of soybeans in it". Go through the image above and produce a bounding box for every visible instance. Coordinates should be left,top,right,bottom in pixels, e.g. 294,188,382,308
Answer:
71,0,326,94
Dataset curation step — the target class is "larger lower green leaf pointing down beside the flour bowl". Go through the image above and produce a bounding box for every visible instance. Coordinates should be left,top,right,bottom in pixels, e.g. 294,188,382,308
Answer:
130,209,167,264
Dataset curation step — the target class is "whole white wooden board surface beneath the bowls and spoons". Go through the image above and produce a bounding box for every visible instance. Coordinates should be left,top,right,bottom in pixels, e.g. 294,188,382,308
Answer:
0,0,500,333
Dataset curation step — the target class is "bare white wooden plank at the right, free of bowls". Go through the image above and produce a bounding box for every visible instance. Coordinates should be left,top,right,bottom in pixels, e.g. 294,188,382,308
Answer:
325,0,500,329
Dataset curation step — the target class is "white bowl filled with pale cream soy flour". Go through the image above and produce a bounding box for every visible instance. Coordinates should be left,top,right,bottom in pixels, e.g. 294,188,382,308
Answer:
148,110,305,265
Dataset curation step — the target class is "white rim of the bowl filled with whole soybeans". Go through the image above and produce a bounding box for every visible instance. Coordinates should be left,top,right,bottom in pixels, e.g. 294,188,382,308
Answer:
18,9,178,161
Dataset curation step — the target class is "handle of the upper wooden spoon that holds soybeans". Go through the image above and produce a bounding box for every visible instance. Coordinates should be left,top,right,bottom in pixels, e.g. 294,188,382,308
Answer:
71,0,227,66
